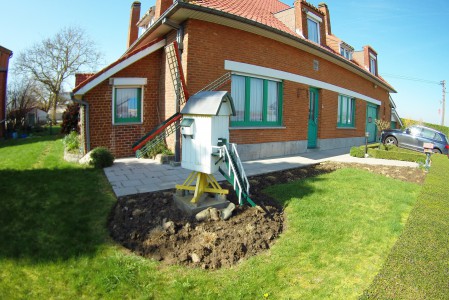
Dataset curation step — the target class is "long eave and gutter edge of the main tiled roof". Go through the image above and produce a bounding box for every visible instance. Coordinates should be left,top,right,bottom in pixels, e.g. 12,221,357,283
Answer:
124,1,397,93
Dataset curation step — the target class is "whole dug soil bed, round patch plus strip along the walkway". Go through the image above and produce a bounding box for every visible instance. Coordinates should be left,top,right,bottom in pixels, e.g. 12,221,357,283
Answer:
108,162,425,269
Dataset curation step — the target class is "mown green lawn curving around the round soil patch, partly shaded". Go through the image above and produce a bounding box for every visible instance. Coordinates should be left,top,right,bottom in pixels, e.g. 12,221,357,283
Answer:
0,136,421,299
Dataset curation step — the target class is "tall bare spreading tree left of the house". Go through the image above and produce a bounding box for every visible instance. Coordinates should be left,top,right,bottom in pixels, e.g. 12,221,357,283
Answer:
15,27,102,123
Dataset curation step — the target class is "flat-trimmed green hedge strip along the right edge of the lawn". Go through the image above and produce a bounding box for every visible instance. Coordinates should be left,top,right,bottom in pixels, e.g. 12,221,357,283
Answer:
361,155,449,299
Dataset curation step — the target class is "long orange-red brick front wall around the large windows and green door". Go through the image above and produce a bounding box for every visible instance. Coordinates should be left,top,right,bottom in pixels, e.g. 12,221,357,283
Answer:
185,20,390,144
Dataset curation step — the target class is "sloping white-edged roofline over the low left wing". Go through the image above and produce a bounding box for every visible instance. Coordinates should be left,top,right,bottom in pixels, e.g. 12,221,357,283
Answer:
73,40,166,99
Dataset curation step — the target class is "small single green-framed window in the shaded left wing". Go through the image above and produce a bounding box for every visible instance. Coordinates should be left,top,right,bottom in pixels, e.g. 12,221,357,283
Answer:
114,87,142,124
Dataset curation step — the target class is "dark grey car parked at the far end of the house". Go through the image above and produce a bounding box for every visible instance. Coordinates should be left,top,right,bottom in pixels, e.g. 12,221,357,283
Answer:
380,125,449,154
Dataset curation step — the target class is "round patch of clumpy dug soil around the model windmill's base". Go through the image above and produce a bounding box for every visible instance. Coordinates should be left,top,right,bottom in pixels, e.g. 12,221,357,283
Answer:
110,192,283,269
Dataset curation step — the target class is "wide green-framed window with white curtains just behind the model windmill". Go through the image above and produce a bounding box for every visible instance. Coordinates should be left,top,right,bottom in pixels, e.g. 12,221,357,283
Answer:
231,75,282,126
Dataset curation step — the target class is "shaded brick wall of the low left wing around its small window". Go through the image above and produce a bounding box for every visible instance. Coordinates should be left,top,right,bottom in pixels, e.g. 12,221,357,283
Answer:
84,50,164,157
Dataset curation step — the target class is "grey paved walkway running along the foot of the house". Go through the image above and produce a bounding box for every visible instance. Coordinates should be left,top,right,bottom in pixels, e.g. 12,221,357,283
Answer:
104,148,418,197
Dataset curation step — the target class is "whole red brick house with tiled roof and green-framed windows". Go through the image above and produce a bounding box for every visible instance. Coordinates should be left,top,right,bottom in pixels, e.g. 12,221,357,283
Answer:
73,0,396,160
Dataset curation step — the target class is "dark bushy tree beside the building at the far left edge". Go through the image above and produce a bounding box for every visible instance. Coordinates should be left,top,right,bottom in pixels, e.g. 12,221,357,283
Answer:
6,79,38,130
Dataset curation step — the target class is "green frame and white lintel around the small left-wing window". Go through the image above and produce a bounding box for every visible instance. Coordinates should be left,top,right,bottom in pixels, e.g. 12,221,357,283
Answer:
109,77,147,125
